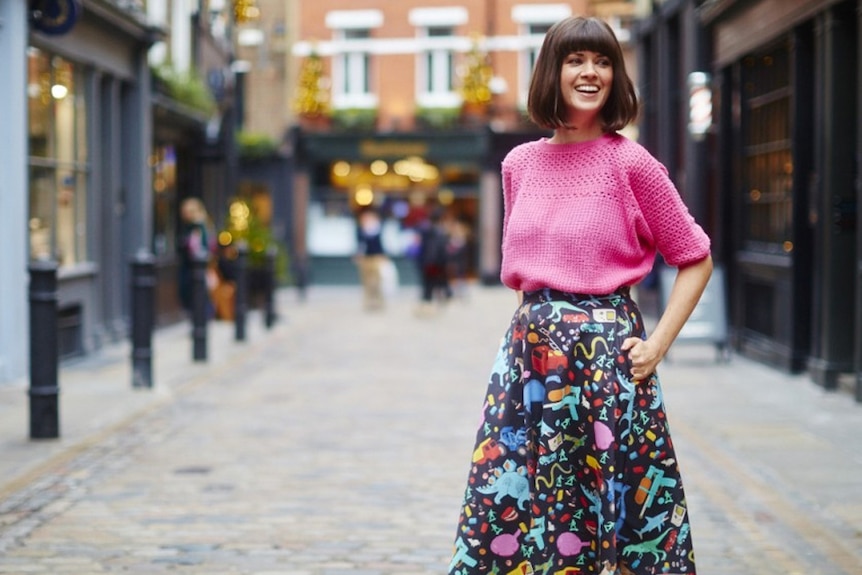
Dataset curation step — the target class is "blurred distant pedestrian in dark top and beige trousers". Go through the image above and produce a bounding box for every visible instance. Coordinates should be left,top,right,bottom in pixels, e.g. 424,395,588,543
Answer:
354,207,388,311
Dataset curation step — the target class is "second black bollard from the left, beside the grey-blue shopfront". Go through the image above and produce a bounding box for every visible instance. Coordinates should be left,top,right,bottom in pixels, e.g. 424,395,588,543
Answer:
132,249,156,387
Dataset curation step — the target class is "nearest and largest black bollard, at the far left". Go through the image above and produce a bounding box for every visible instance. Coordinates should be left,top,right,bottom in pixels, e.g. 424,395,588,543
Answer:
29,261,60,439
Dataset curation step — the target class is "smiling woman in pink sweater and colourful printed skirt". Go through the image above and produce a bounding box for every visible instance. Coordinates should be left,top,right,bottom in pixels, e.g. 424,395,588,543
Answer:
449,18,712,575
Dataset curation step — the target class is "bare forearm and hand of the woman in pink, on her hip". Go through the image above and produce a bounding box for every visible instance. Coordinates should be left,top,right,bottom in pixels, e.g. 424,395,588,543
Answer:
622,256,712,381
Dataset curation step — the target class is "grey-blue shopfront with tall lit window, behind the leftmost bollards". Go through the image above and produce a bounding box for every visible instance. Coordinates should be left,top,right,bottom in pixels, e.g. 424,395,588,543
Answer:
26,3,154,357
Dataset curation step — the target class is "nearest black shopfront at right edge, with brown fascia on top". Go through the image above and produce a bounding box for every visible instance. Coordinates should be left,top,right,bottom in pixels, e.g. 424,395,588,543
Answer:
703,0,859,388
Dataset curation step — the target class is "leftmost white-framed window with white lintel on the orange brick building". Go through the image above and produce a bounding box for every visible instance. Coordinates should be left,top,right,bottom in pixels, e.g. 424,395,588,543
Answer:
326,10,383,110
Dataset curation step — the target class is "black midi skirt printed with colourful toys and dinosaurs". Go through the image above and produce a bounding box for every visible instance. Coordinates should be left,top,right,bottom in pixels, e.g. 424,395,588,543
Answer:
449,289,695,575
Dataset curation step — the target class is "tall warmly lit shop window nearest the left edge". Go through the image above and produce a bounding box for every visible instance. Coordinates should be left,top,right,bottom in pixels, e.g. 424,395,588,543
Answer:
27,47,88,266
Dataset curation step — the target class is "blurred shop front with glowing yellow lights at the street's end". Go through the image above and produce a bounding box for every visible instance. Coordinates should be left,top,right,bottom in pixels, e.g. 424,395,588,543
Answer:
293,130,492,284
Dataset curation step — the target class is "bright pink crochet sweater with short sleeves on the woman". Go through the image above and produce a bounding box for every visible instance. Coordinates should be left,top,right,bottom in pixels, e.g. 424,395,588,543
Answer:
500,134,710,295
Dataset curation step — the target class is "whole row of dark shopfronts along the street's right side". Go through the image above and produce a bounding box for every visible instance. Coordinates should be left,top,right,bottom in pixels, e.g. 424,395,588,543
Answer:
636,0,862,400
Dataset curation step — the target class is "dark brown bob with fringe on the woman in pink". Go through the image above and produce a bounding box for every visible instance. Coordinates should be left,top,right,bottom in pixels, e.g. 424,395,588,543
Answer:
527,17,638,132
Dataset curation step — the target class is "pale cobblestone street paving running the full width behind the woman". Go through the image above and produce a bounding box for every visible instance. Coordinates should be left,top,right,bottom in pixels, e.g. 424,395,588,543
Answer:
0,287,862,575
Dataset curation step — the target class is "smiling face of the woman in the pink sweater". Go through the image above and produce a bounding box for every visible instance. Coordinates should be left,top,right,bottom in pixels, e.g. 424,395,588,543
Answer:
560,50,614,122
